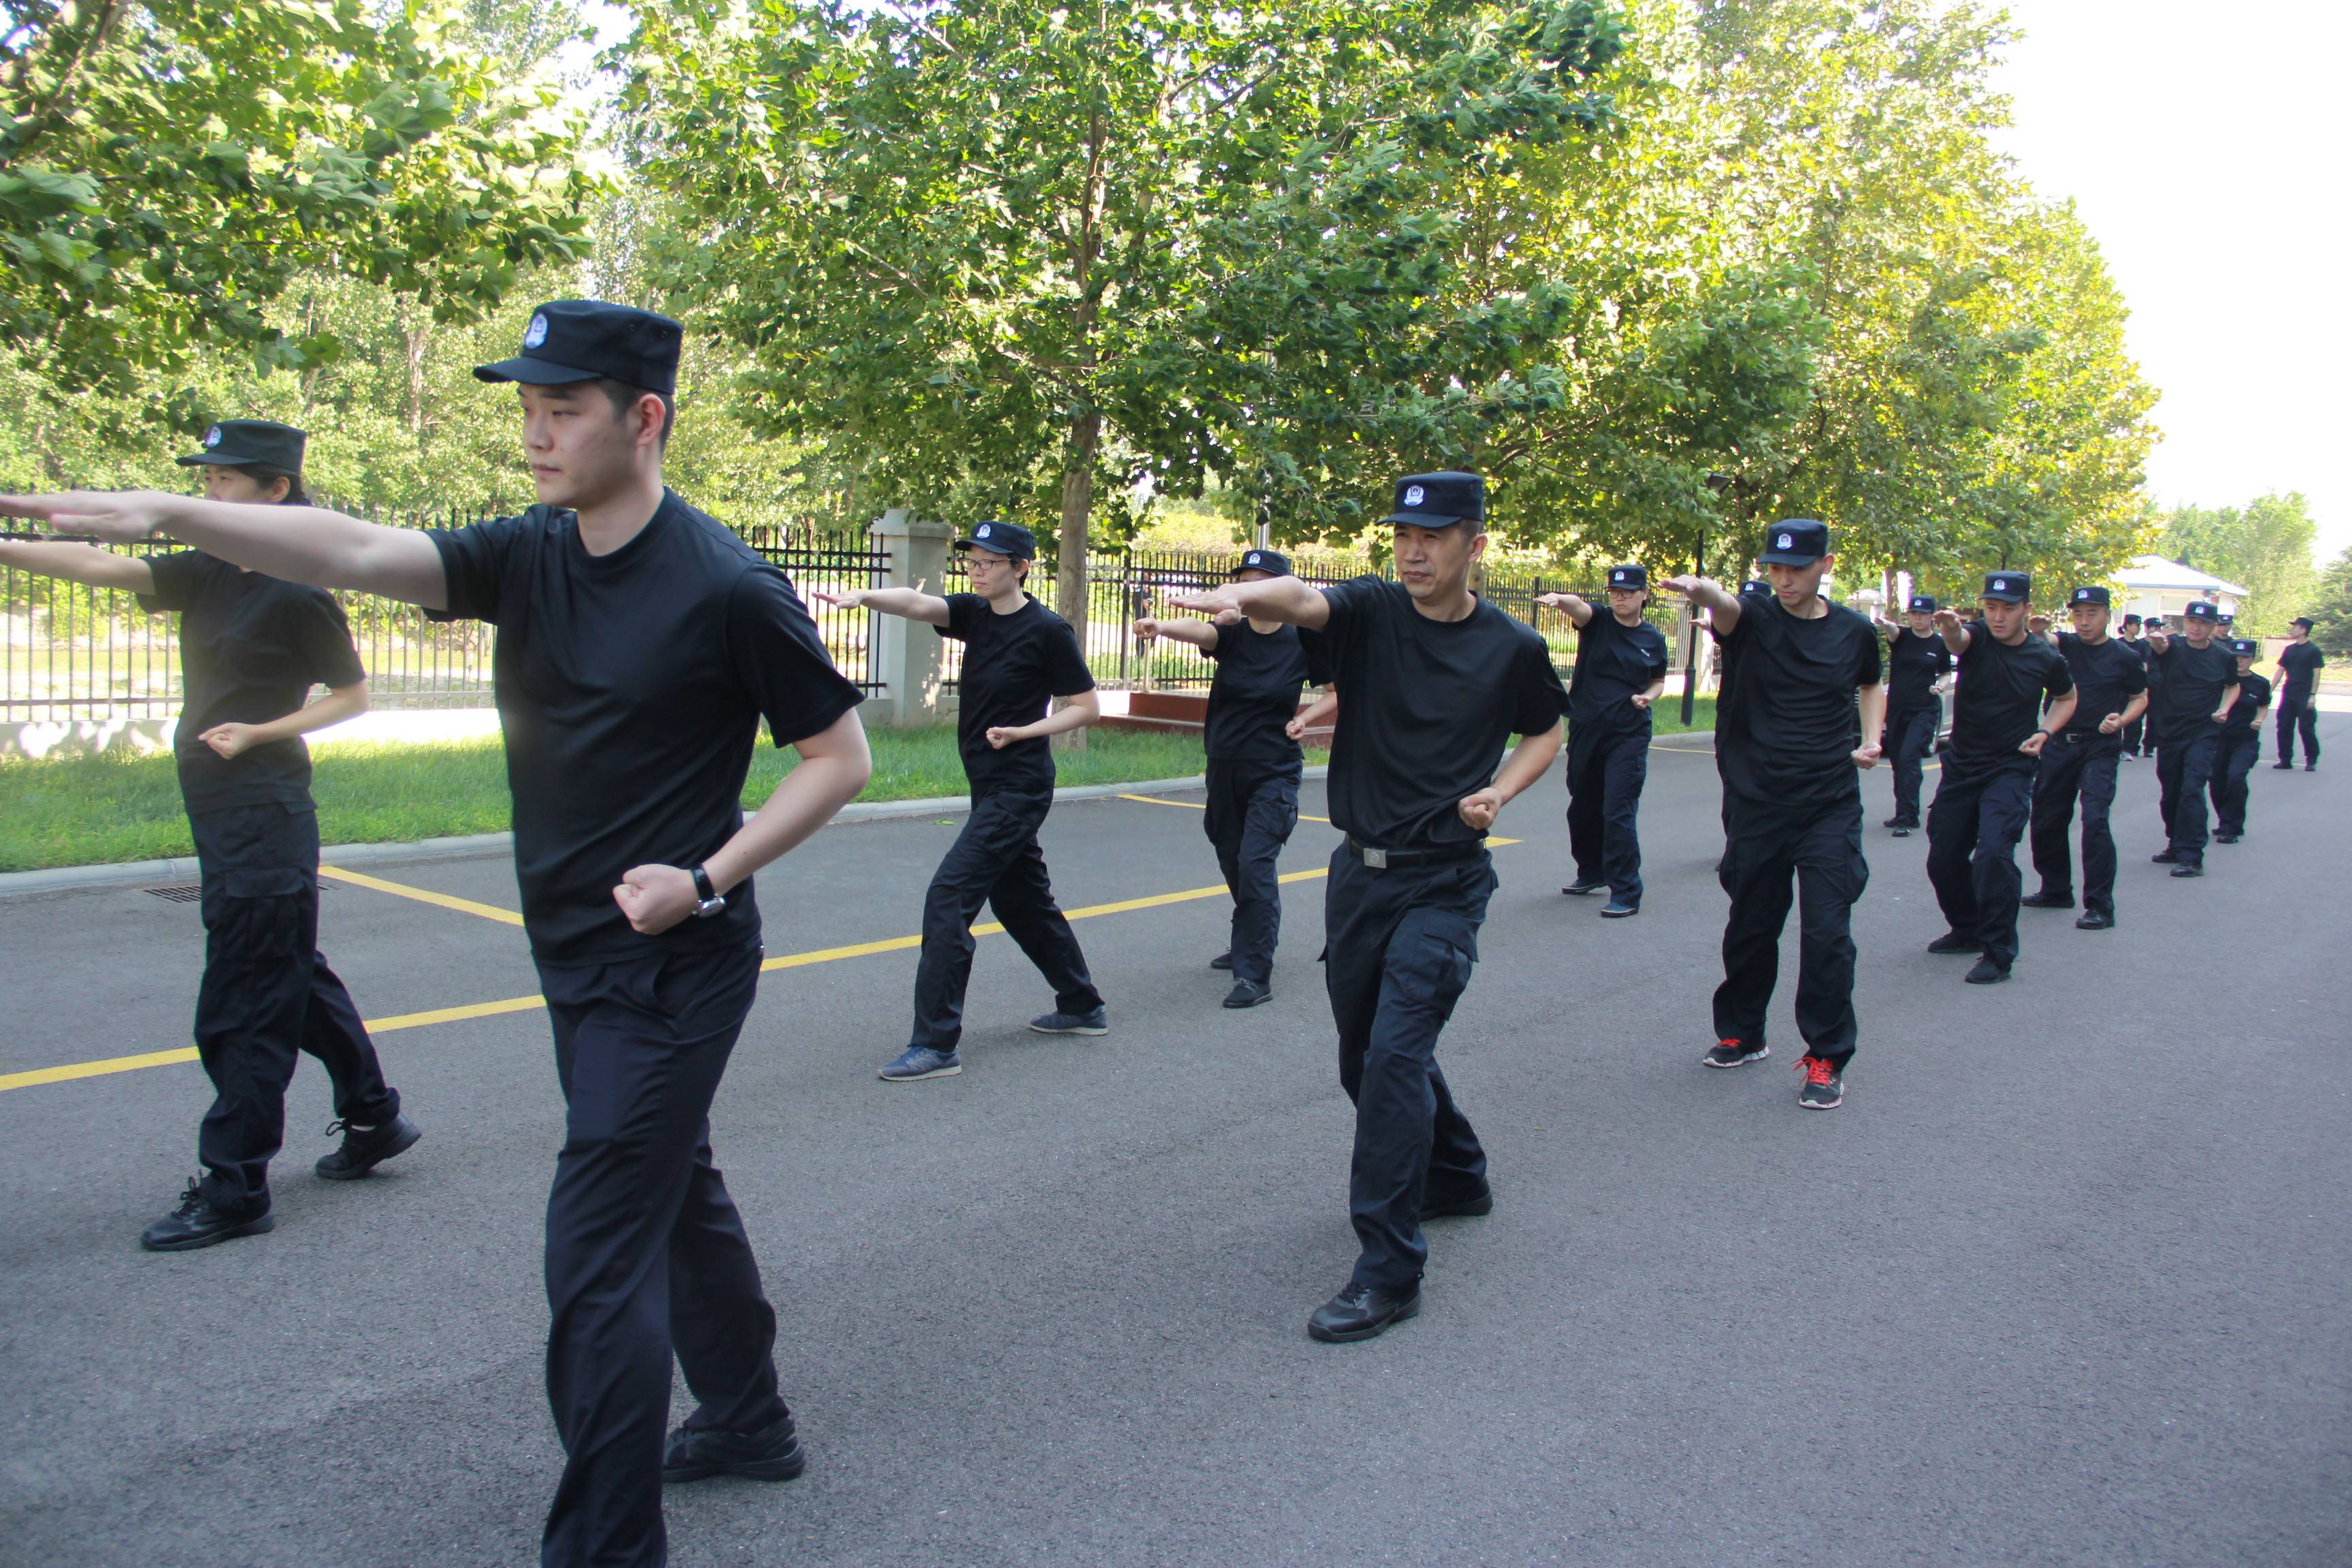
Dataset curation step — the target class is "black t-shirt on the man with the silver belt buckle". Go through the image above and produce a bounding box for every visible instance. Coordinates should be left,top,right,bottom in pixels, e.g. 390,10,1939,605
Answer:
1322,576,1569,849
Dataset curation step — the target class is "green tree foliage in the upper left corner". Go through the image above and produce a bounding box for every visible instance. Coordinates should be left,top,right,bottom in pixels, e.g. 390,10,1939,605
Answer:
0,0,600,390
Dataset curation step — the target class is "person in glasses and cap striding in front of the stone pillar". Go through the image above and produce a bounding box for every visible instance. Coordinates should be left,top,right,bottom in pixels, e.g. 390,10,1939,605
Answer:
811,519,1110,1083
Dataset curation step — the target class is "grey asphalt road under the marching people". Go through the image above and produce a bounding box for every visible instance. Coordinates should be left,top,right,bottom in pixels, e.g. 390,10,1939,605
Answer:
0,717,2352,1568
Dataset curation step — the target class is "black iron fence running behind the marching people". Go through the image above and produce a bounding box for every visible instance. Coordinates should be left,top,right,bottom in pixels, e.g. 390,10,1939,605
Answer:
0,521,1675,721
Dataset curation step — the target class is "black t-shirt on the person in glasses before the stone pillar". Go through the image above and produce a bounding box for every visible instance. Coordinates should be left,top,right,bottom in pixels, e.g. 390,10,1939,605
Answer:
938,592,1094,795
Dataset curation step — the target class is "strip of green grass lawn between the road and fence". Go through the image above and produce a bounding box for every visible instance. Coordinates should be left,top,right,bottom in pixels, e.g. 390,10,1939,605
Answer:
0,698,1714,872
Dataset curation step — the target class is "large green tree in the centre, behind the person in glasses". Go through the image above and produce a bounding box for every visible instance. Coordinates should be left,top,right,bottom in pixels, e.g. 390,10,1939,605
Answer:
625,0,1618,649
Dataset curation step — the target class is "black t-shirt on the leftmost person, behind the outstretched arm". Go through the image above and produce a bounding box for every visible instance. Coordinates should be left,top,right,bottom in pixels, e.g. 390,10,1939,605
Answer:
139,550,367,811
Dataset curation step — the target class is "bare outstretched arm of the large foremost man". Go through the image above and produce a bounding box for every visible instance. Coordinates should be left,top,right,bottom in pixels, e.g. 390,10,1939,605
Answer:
0,489,449,609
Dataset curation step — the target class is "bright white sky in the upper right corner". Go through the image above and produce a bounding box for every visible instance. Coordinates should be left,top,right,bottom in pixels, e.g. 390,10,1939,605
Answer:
2002,0,2352,559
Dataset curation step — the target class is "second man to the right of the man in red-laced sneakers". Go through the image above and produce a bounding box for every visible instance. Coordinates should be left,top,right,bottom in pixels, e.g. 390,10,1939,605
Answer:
2018,583,2147,931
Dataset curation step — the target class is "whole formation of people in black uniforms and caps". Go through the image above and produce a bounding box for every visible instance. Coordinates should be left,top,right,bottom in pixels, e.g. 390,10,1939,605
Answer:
0,301,2317,1566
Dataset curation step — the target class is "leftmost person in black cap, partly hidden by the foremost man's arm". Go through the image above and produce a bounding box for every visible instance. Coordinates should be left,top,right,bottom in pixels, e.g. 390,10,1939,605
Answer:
0,419,421,1253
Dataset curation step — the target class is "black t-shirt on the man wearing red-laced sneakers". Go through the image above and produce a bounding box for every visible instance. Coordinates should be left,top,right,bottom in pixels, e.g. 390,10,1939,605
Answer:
1714,597,1884,804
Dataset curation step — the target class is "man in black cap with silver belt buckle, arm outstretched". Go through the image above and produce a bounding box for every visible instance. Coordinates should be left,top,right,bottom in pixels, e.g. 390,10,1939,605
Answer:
1171,472,1567,1342
